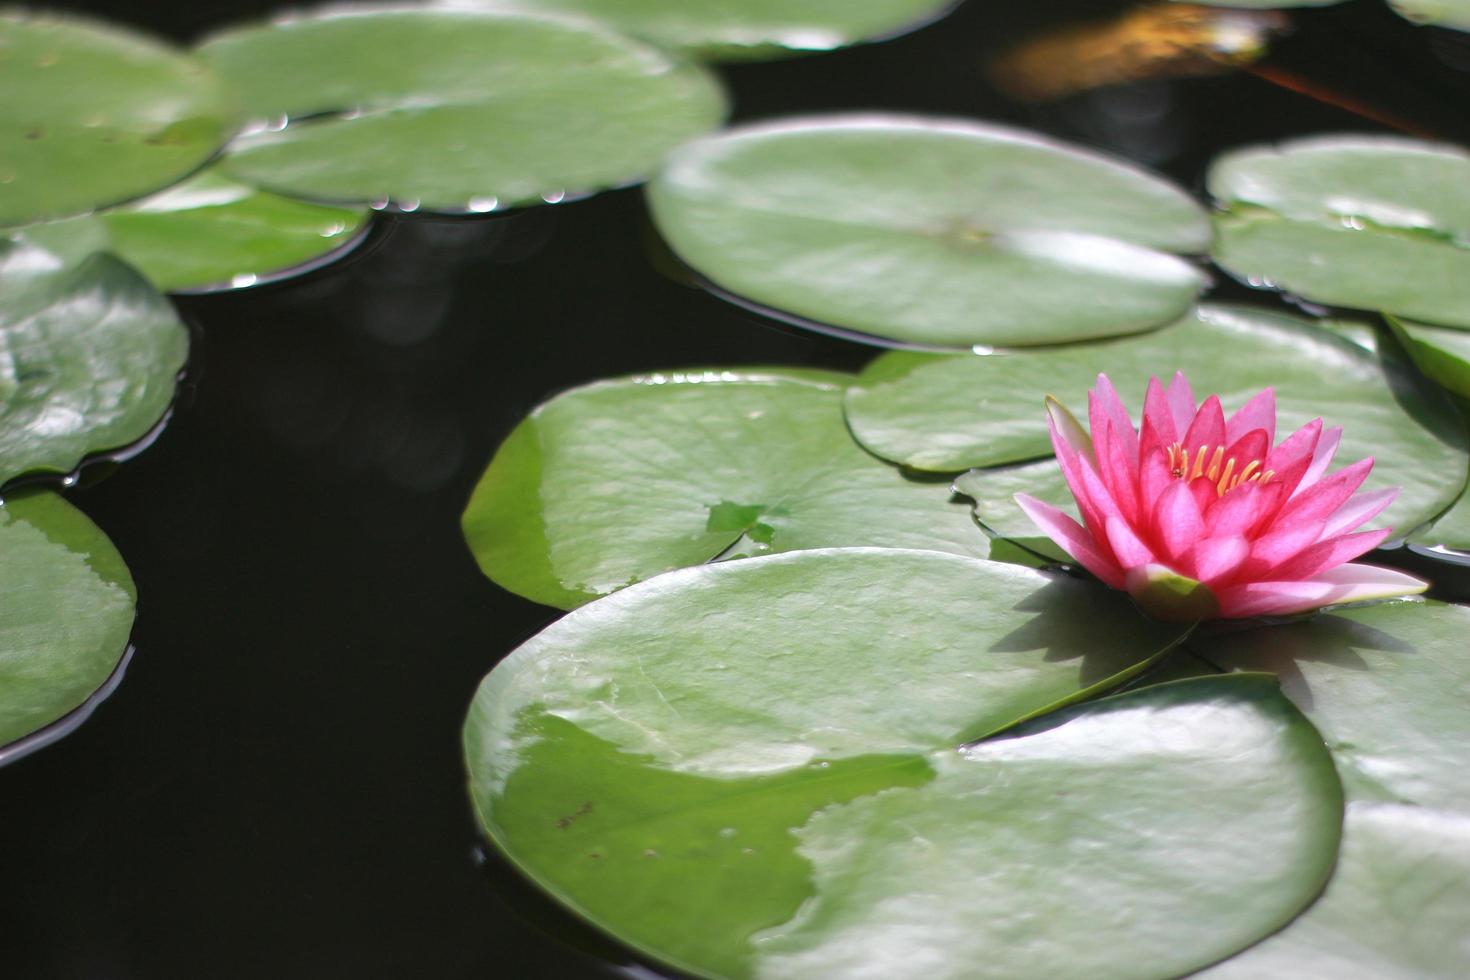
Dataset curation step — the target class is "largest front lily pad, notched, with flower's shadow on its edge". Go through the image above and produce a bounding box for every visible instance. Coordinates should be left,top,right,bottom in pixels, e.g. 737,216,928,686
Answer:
465,550,1341,979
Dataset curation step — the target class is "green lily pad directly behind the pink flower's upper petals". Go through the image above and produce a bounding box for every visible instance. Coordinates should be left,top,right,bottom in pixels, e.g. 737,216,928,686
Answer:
845,304,1470,532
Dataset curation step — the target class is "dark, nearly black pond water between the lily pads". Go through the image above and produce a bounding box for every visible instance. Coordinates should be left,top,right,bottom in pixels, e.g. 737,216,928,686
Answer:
0,0,1470,979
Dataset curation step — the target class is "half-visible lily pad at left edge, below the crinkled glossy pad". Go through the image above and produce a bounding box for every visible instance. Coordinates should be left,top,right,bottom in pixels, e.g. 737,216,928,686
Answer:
0,491,137,748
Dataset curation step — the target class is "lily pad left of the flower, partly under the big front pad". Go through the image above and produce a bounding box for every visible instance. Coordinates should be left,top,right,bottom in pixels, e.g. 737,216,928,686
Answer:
463,369,988,608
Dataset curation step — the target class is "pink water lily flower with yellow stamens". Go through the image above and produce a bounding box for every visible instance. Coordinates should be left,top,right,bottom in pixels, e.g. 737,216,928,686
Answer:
1016,373,1426,621
